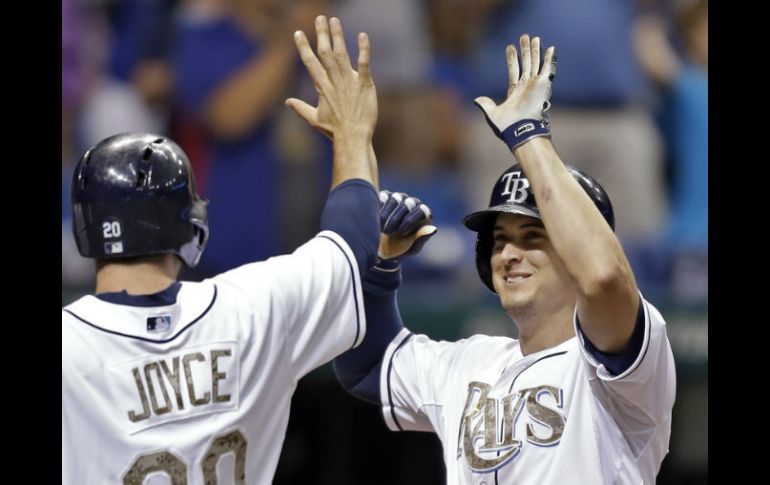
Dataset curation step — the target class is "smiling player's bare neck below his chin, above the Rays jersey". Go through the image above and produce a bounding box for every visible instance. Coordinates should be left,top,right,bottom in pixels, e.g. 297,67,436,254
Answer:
510,305,575,355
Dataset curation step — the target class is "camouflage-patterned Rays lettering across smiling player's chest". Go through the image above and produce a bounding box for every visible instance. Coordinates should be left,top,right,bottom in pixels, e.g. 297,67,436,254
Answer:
457,382,566,473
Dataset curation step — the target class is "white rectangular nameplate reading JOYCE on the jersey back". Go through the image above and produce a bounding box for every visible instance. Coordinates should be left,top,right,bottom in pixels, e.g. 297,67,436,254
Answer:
110,342,239,433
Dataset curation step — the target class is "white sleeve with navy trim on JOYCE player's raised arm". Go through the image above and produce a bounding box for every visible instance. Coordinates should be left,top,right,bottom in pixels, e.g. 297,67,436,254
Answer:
215,231,366,379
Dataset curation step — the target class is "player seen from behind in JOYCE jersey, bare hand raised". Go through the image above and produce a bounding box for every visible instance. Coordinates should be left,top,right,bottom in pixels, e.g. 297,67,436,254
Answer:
62,16,379,485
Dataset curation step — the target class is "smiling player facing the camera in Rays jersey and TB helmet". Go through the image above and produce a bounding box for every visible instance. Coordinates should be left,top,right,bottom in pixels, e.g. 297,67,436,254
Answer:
334,35,676,485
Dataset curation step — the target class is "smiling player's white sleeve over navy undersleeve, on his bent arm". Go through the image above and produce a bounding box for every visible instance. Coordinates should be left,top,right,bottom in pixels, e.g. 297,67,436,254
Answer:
380,328,463,432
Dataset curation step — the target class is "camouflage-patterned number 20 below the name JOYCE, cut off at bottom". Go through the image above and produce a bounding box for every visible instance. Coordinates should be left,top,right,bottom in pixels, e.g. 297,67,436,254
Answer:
123,431,246,485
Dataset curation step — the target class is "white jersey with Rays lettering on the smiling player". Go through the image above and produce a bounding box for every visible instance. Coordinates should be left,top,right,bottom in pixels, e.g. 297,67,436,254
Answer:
380,294,676,485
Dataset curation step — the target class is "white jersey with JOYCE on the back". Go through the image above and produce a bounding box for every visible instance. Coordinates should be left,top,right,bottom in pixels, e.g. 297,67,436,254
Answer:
62,231,366,485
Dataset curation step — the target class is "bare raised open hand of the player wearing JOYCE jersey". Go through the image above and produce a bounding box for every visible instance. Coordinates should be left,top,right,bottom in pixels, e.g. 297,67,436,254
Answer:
286,15,377,140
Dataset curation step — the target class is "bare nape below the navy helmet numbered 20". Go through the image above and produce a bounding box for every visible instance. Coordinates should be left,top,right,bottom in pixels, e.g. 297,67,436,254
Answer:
96,254,182,295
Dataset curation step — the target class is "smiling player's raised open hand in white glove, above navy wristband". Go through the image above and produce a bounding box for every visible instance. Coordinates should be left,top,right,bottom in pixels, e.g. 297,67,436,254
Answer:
474,34,556,137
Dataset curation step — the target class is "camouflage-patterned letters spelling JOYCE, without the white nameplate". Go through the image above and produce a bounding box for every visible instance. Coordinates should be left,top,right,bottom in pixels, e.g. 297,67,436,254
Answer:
128,349,232,423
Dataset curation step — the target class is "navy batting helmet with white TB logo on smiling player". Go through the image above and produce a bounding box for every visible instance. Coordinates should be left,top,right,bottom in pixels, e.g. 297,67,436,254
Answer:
463,163,615,293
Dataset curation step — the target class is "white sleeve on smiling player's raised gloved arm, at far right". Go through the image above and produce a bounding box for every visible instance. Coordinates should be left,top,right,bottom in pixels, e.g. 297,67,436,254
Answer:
574,297,676,434
